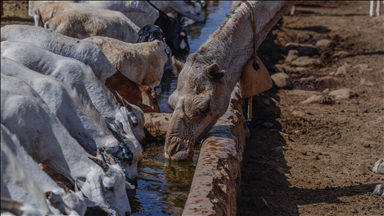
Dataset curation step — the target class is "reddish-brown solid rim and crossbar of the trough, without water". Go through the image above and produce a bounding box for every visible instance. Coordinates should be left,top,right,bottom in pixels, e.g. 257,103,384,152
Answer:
145,86,249,215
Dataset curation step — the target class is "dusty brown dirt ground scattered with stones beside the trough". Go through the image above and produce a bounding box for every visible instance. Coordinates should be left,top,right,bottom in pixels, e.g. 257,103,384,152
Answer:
1,1,384,216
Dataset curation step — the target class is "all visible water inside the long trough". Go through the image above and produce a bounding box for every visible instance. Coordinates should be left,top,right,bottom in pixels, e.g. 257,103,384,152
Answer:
129,1,231,216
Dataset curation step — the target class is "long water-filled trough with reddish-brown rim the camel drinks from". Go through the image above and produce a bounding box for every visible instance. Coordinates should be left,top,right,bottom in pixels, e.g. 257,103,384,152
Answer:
134,1,249,215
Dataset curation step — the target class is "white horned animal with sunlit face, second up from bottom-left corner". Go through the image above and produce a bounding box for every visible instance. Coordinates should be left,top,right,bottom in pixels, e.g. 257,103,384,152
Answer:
1,74,131,215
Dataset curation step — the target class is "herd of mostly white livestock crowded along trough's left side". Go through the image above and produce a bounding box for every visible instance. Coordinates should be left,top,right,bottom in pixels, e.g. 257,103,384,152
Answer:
1,0,204,215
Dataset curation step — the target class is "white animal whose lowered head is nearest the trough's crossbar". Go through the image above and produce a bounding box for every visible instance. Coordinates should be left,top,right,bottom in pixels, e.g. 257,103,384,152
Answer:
1,41,145,180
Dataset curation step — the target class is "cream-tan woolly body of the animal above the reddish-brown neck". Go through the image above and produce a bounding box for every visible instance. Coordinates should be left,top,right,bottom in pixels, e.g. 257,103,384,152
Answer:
84,36,168,88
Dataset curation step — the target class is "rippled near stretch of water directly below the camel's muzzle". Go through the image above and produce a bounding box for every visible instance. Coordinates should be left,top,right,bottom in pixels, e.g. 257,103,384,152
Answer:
129,143,198,215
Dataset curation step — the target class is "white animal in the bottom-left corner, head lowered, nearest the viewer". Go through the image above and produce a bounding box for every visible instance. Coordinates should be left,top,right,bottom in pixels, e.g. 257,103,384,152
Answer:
1,125,87,215
